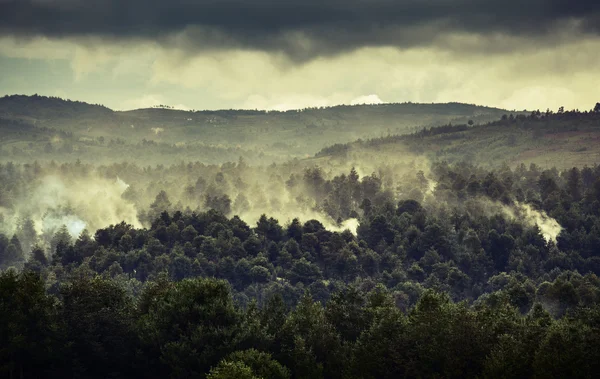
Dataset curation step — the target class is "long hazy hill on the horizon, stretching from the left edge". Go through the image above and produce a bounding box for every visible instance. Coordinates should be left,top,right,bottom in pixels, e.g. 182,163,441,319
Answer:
0,95,508,163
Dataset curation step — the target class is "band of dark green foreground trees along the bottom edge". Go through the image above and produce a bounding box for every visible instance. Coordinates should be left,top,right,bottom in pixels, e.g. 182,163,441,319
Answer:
0,271,600,379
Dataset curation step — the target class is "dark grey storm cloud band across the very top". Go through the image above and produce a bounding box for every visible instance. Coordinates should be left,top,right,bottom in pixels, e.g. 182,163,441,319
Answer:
0,0,600,59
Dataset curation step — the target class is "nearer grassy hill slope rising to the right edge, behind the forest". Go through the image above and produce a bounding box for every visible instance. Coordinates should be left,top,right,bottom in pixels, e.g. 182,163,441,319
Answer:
315,110,600,168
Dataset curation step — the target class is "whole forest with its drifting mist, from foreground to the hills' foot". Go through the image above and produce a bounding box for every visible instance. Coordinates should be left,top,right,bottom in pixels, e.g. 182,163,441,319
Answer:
0,101,600,379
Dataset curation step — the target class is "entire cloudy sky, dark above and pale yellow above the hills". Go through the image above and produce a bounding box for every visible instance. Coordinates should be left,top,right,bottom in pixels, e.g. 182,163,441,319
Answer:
0,0,600,110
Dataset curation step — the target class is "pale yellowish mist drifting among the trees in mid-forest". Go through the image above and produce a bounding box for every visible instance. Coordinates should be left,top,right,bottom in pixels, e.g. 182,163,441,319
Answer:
2,147,562,260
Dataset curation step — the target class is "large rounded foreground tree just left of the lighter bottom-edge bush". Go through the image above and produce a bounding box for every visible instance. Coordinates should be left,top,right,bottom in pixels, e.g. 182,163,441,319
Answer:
138,278,243,377
